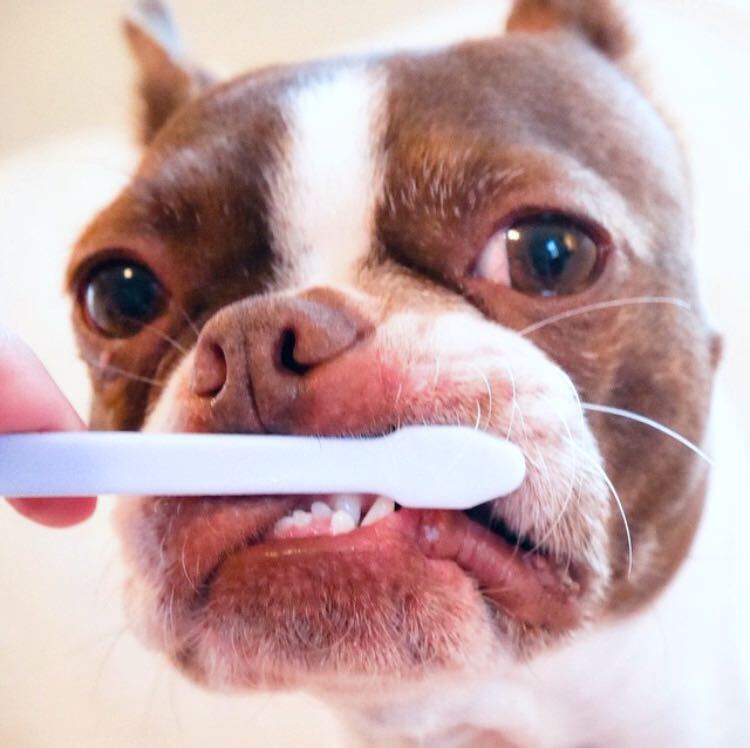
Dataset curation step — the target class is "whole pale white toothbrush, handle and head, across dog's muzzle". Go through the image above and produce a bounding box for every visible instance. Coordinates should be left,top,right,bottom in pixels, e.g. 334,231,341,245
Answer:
0,426,525,509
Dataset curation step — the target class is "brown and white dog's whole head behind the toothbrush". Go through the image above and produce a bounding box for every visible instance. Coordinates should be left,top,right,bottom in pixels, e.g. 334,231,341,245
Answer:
69,2,713,690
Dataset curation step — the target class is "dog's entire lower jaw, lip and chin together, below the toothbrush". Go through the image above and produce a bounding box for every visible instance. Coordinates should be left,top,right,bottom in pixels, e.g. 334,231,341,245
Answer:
118,490,600,696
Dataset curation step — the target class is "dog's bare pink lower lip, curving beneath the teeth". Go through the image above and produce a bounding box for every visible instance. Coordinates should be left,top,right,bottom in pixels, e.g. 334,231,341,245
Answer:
197,500,585,633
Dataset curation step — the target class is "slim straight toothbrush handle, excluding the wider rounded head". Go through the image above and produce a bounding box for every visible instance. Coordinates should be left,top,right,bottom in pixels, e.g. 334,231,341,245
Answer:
0,432,382,496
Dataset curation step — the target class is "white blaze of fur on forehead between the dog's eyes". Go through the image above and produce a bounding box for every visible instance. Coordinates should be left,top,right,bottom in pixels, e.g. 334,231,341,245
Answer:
270,67,385,285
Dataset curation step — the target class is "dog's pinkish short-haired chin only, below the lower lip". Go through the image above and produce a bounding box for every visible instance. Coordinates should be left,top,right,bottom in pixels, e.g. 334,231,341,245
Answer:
174,548,494,693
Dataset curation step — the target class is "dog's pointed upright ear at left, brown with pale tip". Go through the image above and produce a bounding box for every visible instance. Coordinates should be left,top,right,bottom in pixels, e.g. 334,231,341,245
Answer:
124,0,212,145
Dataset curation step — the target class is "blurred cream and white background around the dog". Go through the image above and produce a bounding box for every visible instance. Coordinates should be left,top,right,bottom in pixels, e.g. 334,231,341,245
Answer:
0,0,750,748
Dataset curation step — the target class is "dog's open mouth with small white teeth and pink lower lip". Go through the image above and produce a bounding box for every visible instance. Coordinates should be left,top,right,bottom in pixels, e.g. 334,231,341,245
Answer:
195,494,587,633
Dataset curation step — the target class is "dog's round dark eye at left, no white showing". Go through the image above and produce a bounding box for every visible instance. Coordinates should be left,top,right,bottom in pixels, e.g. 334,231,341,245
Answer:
80,260,166,338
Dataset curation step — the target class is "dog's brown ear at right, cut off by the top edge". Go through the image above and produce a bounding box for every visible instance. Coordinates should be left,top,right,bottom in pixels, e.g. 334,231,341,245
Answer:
506,0,630,60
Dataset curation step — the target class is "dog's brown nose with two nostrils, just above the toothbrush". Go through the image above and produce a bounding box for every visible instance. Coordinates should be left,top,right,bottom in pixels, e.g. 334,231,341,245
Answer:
192,288,373,432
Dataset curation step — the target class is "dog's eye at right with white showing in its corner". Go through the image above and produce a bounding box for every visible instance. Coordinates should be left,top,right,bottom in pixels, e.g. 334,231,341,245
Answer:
474,213,601,296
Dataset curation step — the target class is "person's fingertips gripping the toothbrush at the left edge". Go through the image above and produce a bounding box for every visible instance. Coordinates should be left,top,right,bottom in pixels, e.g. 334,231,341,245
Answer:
0,328,96,527
